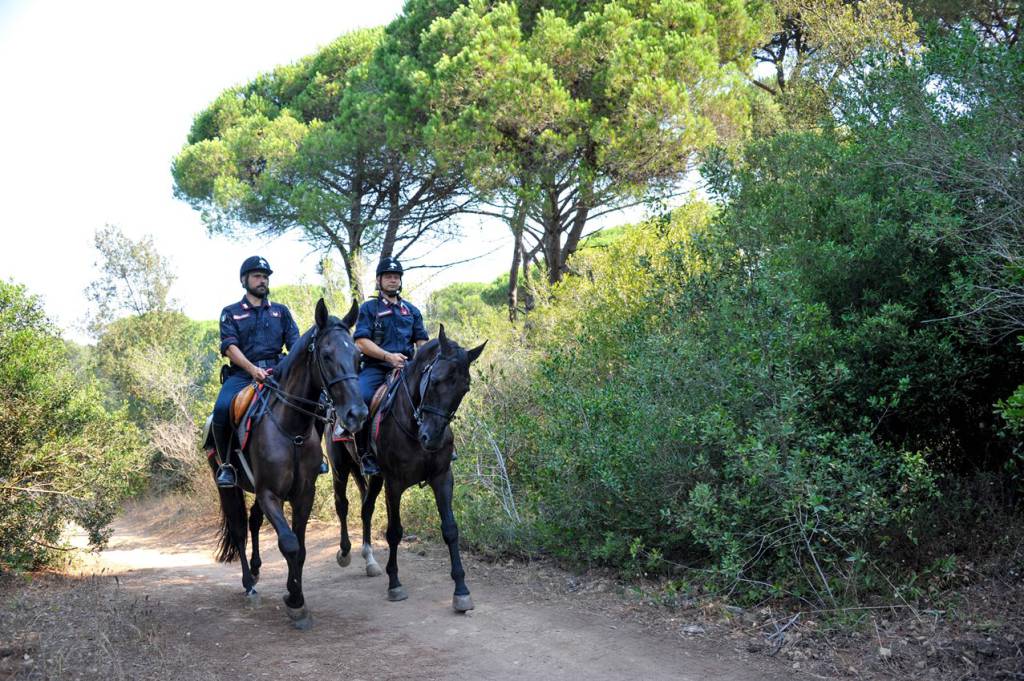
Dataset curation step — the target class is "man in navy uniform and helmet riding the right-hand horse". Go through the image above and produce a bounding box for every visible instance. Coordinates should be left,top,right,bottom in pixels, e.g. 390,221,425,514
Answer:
352,256,430,475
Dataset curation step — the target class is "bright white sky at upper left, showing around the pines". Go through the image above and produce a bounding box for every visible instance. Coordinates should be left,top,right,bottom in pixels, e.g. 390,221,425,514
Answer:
0,0,511,340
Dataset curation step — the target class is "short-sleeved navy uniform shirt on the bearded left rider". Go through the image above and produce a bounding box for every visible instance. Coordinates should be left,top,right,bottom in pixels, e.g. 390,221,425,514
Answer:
220,298,299,364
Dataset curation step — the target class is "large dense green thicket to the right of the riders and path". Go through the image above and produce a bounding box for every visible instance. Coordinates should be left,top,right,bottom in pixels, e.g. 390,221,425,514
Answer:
405,25,1024,607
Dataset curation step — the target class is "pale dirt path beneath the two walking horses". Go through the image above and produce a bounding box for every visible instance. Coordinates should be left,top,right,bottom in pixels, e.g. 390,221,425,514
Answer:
64,509,790,681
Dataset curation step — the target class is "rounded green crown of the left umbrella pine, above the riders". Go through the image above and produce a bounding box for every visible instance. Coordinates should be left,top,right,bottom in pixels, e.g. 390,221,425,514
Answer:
173,29,462,293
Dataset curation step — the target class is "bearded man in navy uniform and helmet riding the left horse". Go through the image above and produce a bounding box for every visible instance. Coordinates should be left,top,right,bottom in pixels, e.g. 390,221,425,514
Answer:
212,255,299,487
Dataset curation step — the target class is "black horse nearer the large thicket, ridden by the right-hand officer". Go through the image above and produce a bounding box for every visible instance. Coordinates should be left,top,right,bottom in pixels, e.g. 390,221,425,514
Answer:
329,325,486,612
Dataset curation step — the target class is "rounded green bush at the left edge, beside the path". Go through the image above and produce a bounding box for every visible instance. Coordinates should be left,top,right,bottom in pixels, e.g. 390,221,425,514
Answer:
0,282,143,568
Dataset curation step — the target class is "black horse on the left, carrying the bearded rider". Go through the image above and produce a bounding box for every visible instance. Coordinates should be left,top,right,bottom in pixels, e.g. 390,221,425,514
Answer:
211,299,367,629
